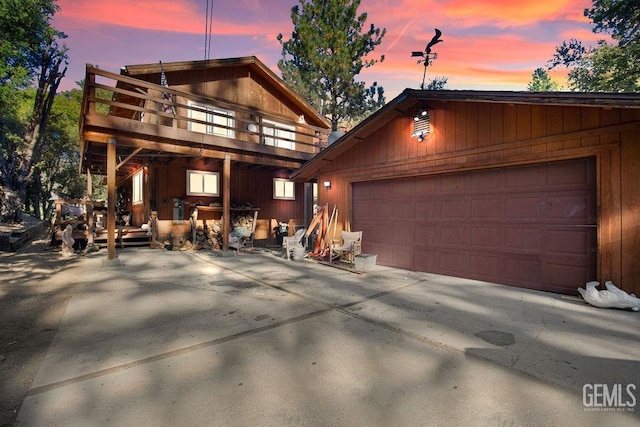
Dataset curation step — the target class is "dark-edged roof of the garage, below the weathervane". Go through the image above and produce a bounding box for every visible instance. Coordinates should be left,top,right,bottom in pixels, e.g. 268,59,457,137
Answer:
290,89,640,181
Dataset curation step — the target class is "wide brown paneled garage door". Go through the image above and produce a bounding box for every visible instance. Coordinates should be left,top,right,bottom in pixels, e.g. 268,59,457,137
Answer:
352,158,597,294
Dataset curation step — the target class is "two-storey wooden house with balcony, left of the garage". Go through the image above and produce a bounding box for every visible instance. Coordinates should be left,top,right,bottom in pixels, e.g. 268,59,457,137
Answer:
80,57,330,259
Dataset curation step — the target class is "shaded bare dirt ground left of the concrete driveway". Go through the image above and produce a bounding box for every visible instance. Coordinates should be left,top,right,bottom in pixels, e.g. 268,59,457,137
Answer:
0,226,79,427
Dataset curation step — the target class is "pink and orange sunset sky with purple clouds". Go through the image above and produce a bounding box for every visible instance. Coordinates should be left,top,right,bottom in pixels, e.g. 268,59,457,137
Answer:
53,0,602,101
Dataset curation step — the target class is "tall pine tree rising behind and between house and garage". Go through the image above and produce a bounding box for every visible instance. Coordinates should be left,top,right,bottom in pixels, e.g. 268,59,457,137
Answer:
277,0,386,130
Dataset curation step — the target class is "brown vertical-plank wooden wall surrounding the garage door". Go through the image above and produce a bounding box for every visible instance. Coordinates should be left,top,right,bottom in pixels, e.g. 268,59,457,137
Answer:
317,101,640,293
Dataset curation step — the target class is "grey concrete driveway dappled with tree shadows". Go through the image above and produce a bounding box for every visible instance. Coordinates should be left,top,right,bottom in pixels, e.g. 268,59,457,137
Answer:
16,249,640,426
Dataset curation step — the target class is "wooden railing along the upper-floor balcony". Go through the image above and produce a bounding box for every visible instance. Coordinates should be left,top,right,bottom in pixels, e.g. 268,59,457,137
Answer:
81,65,330,154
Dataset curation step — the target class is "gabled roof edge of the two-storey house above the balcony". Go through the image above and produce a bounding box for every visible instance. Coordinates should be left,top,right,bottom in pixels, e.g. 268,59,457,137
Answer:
121,56,331,128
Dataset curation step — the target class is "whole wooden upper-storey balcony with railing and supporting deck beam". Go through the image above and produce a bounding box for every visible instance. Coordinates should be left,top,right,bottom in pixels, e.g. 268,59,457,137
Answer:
80,65,330,174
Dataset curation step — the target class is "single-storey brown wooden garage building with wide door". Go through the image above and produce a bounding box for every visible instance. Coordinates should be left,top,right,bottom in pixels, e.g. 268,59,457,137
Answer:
291,89,640,294
